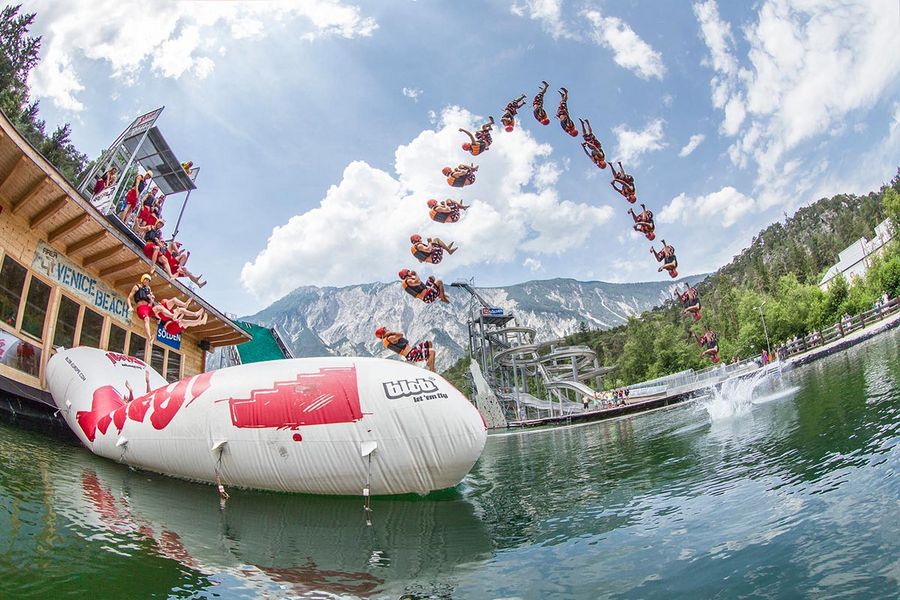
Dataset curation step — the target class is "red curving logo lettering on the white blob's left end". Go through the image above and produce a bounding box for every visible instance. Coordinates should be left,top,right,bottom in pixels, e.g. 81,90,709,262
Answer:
75,373,213,442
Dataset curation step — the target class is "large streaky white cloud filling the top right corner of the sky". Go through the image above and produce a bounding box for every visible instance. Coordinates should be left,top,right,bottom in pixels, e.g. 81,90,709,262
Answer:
694,0,900,197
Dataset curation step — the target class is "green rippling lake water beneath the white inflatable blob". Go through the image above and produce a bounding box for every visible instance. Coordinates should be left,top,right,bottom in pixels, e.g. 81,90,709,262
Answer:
0,333,900,599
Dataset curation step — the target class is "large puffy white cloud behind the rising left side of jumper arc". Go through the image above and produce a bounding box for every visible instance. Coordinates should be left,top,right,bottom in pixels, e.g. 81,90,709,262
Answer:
241,107,613,301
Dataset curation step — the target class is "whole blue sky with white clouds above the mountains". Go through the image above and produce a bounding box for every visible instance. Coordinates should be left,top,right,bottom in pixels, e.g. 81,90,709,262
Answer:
26,0,900,314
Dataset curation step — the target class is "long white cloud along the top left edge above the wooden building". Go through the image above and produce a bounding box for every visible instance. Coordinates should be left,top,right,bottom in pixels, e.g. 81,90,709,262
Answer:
29,0,378,111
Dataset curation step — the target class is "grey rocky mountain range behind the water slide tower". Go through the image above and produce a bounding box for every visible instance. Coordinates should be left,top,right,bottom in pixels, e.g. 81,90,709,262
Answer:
243,275,706,369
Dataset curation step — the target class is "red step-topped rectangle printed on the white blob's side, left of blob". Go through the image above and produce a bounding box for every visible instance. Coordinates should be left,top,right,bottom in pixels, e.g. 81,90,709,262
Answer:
228,367,362,428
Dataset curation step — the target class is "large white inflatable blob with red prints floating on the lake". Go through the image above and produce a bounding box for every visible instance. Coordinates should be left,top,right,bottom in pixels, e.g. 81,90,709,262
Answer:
47,347,487,495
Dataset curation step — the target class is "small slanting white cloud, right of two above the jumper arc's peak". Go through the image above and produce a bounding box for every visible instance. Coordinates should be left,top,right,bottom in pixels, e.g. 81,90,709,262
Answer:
582,10,666,79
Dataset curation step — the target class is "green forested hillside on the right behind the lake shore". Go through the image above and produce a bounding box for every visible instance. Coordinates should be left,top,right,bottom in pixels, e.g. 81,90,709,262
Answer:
567,171,900,386
